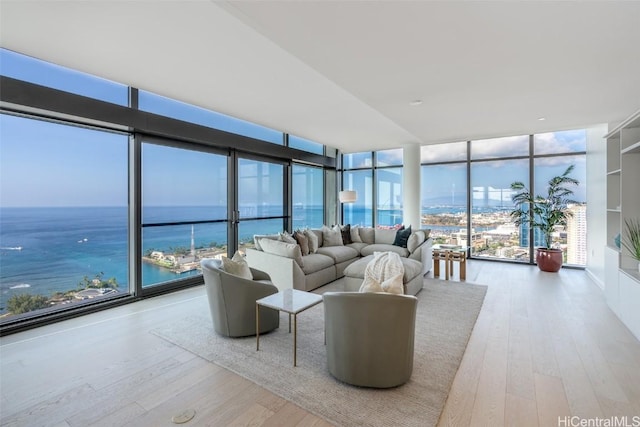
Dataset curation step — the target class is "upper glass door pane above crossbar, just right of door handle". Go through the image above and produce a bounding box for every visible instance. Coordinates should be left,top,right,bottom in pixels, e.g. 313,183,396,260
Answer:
238,159,285,219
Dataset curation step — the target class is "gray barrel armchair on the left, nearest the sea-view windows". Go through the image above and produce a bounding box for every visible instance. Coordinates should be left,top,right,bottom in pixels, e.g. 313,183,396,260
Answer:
200,259,280,337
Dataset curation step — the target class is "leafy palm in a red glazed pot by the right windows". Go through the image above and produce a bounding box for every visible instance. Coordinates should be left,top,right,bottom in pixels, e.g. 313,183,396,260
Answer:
510,165,580,272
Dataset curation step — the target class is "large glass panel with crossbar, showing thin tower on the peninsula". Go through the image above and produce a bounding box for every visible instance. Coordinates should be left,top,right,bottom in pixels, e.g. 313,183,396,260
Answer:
142,143,227,287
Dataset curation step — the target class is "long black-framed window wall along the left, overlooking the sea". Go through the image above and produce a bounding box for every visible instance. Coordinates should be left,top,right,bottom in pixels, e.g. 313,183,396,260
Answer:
0,48,336,333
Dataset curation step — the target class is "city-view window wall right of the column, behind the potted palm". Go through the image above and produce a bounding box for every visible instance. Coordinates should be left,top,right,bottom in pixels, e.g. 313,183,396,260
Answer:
422,130,586,266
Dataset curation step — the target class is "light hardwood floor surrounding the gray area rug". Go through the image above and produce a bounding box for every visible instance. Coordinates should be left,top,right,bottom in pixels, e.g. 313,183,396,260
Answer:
0,261,640,427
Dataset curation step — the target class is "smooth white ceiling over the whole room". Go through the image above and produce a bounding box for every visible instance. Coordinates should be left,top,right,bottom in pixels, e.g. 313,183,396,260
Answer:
0,0,640,152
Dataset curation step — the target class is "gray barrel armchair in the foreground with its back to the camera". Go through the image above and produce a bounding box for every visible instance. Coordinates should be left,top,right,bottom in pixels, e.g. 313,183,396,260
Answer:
323,292,418,388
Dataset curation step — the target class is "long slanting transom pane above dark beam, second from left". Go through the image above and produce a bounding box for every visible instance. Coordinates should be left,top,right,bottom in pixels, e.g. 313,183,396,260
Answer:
138,90,283,145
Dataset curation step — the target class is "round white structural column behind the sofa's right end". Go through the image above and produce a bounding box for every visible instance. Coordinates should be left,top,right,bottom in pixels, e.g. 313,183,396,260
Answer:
402,144,421,230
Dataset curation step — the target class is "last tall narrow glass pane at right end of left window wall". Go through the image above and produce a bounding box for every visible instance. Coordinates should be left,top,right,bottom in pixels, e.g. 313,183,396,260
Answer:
292,165,324,230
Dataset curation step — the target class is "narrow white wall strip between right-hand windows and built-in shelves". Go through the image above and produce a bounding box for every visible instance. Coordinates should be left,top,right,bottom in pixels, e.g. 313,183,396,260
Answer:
586,124,608,288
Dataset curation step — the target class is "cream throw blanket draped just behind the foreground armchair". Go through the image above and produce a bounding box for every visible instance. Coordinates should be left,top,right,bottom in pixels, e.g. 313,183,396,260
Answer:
360,252,404,294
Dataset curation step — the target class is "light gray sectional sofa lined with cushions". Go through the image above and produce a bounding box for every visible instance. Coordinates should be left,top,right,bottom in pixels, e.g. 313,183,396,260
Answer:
246,227,433,291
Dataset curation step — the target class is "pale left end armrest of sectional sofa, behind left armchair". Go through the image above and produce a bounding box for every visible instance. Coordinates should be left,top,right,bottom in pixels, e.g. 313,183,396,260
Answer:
246,249,305,291
